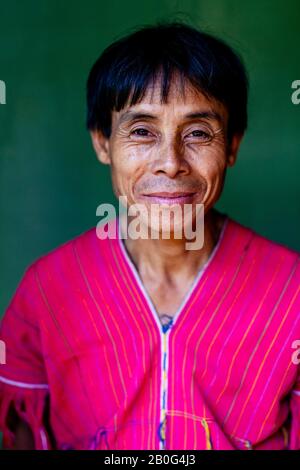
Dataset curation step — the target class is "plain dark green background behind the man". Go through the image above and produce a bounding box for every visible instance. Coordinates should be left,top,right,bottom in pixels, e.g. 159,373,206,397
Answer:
0,0,300,315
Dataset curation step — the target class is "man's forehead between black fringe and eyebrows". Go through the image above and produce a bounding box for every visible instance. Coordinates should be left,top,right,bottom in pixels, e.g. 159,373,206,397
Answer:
112,77,227,125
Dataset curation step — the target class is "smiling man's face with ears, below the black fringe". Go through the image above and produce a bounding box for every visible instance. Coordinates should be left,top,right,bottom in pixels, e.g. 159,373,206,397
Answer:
92,76,240,234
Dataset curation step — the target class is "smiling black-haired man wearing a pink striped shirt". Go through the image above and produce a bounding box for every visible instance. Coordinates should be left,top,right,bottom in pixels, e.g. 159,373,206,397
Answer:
0,23,300,449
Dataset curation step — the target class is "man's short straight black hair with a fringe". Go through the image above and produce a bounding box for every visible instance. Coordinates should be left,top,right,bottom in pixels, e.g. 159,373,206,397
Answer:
86,22,248,141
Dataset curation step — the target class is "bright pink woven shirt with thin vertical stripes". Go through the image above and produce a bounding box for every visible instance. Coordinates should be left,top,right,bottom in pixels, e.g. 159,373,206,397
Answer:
0,217,300,450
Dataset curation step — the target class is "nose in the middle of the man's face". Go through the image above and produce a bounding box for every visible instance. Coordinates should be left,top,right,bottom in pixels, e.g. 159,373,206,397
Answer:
152,138,190,178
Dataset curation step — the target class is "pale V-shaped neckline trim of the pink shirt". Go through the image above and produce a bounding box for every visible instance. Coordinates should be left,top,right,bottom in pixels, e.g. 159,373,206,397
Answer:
116,211,229,333
